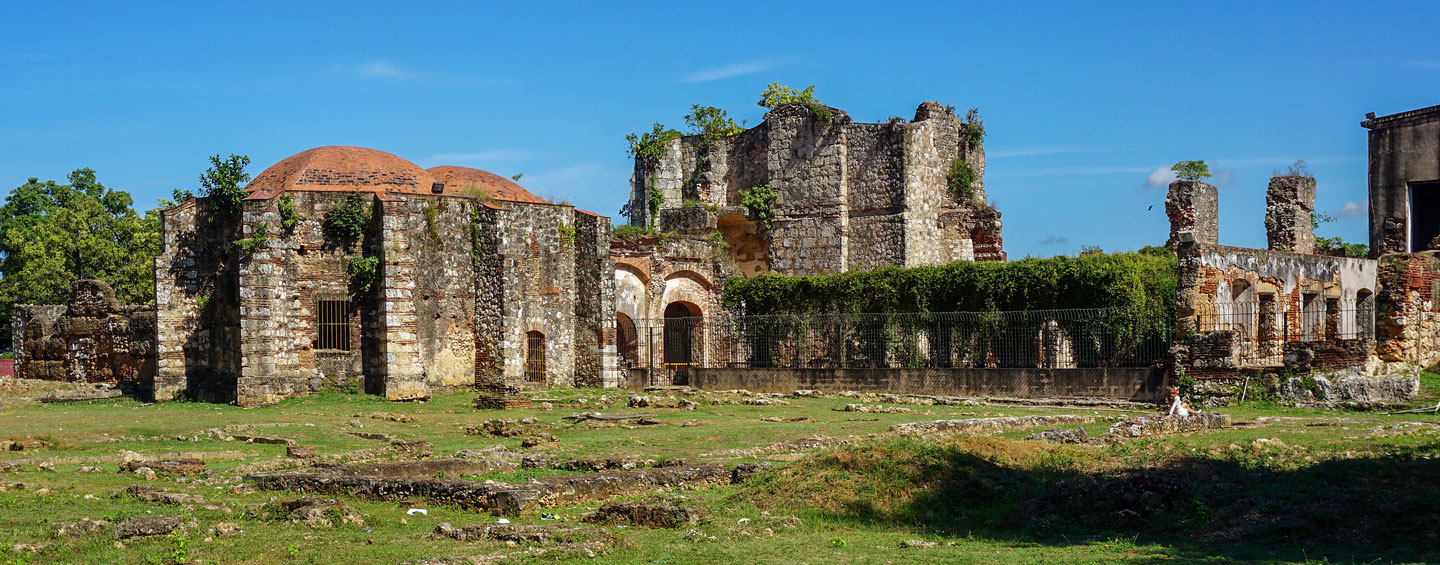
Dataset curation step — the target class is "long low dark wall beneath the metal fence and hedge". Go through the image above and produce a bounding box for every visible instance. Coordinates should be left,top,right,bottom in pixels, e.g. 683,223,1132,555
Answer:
690,368,1165,402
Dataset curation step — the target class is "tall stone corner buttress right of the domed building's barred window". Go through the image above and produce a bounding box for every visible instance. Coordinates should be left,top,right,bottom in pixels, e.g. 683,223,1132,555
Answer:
377,195,431,401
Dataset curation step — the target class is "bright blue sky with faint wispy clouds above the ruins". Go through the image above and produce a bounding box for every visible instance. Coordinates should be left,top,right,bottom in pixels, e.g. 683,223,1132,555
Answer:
0,1,1440,258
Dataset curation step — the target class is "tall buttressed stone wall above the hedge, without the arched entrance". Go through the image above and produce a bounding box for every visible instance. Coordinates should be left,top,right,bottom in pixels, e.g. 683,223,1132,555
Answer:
631,102,1005,282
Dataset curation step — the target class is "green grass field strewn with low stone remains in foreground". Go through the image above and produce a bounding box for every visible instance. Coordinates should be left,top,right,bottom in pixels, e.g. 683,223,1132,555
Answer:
0,375,1440,564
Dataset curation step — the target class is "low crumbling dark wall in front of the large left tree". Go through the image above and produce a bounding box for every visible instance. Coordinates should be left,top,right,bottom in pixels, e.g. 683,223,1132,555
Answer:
12,280,156,385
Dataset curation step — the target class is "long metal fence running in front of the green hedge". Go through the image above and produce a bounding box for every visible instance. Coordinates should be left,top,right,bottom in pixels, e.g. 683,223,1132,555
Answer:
621,308,1172,370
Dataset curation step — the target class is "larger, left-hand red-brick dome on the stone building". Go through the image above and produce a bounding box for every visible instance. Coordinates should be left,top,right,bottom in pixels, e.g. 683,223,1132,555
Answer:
245,146,435,195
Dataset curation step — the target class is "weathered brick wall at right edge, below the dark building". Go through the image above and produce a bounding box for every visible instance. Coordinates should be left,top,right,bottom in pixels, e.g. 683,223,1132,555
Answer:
1375,251,1440,370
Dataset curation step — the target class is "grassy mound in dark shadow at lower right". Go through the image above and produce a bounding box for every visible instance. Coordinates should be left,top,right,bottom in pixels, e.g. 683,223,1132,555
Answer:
753,440,1440,562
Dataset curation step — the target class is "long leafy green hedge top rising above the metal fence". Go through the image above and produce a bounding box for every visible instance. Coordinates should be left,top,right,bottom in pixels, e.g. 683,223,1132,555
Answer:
723,248,1175,314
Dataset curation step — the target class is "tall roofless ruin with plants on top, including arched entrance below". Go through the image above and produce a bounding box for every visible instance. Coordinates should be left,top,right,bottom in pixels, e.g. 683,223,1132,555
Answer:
611,102,1005,382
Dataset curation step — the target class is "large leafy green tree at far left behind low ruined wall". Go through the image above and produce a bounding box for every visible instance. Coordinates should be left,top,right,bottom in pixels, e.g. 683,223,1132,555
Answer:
0,169,160,344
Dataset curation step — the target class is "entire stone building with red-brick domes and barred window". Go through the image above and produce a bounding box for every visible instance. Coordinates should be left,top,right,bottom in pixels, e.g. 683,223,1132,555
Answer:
154,147,619,405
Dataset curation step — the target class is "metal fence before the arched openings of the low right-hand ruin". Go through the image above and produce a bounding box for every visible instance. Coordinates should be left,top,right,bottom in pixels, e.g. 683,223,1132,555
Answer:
1194,295,1375,366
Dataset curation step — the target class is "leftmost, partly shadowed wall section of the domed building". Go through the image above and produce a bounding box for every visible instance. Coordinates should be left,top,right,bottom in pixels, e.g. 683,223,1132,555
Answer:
154,197,240,401
